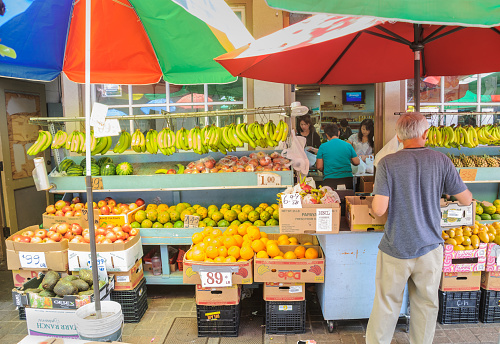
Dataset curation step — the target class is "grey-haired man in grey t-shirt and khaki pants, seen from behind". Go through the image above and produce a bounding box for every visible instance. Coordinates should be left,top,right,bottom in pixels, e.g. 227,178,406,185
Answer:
366,113,472,344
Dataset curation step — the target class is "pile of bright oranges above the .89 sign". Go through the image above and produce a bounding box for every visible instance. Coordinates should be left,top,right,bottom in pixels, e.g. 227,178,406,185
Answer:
186,223,318,263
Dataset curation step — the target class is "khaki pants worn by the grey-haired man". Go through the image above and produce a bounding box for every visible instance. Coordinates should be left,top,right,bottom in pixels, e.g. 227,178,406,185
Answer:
366,245,443,344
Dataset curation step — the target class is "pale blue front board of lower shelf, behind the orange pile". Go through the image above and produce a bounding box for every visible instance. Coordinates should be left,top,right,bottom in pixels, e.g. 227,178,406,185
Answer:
141,226,279,245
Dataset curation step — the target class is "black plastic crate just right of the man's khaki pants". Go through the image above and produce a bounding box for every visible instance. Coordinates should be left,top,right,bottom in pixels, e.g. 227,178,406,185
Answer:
438,290,481,324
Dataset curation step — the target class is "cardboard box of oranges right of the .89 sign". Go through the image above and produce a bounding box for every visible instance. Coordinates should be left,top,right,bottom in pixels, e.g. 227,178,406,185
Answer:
254,245,325,283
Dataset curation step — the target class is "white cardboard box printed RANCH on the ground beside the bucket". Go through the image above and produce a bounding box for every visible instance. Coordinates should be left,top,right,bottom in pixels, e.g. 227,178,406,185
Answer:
26,293,111,343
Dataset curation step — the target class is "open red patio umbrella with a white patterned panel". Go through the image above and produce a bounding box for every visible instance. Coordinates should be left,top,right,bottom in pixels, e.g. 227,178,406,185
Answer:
215,14,500,106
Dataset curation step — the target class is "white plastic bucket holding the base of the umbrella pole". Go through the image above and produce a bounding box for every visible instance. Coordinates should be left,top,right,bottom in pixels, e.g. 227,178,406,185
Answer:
76,301,123,342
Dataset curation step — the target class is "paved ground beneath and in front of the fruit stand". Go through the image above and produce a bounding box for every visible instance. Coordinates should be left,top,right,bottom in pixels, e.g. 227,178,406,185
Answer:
0,271,500,344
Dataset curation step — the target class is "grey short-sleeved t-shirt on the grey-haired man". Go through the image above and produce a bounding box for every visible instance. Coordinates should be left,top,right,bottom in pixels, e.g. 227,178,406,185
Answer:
373,148,467,259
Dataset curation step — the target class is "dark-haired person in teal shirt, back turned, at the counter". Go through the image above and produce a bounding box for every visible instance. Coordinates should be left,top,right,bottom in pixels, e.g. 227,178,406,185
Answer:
316,124,360,190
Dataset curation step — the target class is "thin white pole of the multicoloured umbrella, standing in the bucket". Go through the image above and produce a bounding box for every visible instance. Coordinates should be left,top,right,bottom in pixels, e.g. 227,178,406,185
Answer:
85,0,101,319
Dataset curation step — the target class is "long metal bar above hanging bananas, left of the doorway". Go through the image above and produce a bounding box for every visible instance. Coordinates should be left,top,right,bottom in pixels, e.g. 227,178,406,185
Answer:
29,105,291,126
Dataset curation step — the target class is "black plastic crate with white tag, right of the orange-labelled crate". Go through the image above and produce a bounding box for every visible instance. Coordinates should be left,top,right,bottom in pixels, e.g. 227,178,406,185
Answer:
266,300,306,334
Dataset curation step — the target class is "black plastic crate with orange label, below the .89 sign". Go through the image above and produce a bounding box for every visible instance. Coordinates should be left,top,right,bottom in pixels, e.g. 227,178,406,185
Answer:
196,304,241,337
